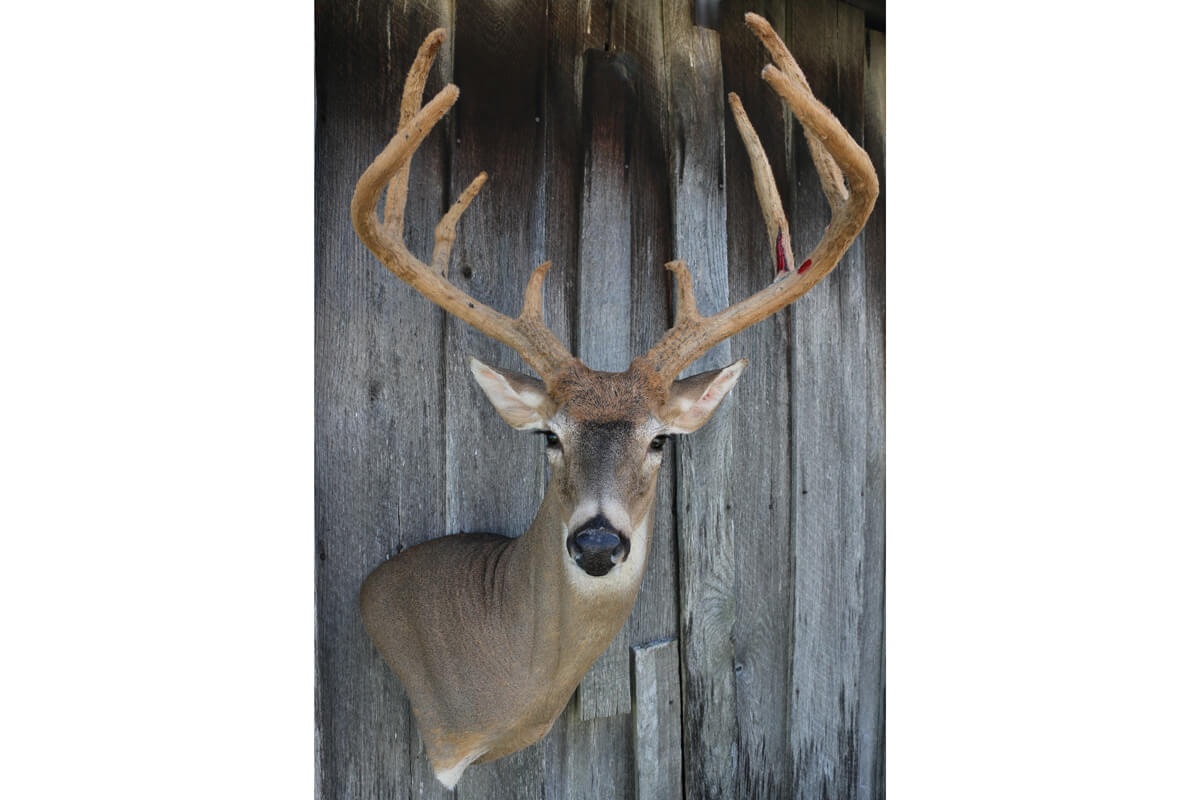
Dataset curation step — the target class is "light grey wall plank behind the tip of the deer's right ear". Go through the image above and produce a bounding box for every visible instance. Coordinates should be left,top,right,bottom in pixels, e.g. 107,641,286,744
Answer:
664,0,737,798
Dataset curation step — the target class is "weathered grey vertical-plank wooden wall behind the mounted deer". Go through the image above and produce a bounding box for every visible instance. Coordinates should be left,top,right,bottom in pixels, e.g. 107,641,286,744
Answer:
316,0,884,799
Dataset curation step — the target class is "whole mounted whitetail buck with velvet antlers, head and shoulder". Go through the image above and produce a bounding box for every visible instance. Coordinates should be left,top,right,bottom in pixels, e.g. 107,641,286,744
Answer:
350,14,878,788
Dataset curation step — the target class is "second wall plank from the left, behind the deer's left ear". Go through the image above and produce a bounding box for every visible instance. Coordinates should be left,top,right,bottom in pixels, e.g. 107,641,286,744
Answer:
445,0,547,798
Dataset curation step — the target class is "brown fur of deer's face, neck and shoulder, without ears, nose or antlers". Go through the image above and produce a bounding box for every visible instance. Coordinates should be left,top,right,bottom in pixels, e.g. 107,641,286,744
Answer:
360,361,676,771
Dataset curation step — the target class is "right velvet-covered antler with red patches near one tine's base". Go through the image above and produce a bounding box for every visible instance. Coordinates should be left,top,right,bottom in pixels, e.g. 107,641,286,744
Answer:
641,13,880,381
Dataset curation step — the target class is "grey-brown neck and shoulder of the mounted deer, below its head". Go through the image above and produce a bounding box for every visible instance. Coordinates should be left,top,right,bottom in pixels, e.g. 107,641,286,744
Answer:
359,484,649,771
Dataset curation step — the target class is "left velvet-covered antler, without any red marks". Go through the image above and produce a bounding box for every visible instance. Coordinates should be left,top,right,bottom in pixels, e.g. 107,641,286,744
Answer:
350,28,574,383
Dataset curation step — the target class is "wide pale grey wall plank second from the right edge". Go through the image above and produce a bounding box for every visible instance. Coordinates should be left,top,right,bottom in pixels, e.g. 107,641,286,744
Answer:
787,1,874,798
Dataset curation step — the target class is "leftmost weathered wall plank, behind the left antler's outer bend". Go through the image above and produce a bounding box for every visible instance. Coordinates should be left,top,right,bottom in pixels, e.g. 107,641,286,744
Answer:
314,1,450,798
